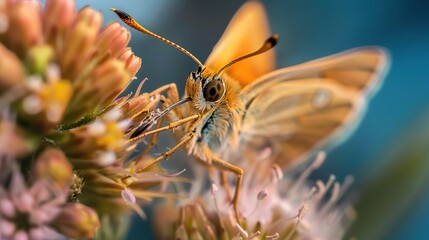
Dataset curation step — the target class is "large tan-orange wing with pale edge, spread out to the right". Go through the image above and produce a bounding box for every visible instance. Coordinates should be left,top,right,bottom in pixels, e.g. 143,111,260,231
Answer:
240,47,389,168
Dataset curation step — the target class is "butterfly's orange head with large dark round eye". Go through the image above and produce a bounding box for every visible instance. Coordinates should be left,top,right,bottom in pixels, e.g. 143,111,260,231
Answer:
186,67,226,111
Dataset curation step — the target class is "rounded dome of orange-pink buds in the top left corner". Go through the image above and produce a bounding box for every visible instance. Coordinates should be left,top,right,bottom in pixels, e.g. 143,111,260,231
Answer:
0,0,141,134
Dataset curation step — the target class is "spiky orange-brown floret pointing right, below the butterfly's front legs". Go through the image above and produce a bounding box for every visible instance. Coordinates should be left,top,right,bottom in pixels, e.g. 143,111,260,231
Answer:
79,154,188,218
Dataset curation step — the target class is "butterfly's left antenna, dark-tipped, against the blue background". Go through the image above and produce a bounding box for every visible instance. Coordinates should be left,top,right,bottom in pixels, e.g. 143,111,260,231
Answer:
110,8,203,67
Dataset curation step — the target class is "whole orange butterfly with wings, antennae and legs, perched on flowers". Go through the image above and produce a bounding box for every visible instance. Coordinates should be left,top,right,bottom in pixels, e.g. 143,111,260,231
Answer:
112,1,389,219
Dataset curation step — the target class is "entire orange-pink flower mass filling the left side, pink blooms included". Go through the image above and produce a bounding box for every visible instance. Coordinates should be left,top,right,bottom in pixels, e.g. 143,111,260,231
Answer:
0,0,176,239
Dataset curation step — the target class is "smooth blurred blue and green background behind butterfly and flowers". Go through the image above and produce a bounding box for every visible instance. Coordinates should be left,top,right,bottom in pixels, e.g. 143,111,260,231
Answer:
71,0,429,239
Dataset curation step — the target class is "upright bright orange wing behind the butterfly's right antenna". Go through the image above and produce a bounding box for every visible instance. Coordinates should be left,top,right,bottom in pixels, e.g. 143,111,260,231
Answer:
205,1,275,86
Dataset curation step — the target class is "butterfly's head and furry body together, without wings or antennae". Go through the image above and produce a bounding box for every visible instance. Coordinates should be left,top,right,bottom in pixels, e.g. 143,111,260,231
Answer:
183,68,243,162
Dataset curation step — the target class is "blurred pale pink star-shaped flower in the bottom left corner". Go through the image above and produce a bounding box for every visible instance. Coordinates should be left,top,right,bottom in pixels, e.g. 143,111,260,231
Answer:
0,166,67,239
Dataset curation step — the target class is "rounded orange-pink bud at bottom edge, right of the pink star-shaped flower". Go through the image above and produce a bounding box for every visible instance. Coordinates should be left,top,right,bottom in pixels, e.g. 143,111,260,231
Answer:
52,203,100,239
